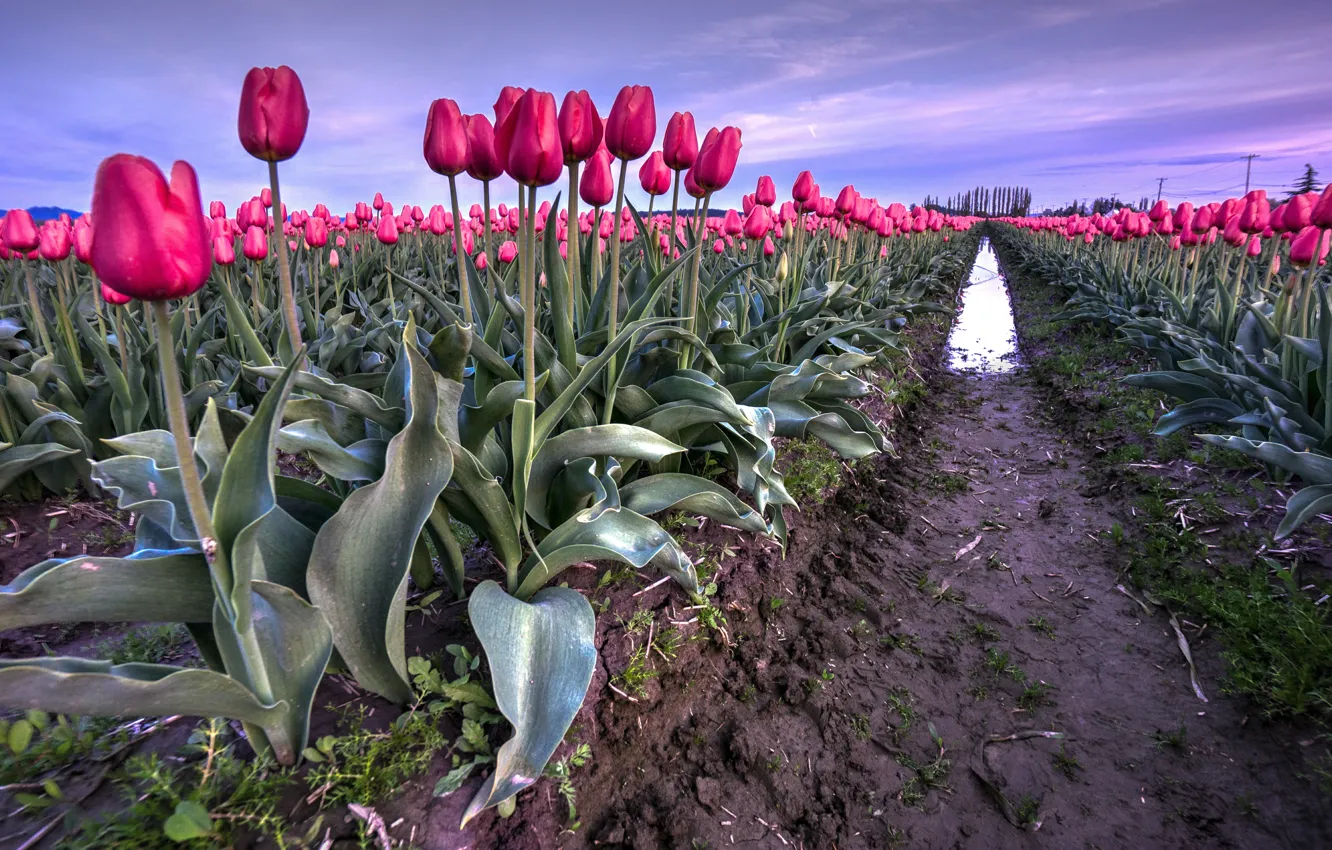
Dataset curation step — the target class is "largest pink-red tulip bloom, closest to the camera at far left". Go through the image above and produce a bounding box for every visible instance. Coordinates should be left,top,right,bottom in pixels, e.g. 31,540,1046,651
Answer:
92,153,213,301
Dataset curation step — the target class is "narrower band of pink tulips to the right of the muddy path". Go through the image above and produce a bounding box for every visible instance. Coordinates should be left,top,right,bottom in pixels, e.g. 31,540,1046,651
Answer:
998,188,1332,538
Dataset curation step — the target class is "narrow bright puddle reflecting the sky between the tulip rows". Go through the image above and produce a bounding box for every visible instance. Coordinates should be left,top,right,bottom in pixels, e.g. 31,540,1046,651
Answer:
948,238,1018,374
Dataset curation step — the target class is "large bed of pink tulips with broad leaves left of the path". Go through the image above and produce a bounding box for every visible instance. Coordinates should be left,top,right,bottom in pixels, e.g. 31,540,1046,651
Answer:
0,67,975,818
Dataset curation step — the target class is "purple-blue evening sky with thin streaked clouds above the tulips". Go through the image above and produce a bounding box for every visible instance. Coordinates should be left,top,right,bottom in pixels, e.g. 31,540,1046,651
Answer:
0,0,1332,214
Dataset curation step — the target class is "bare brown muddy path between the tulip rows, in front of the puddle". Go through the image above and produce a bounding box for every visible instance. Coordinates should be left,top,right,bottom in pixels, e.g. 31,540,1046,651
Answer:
473,261,1332,850
